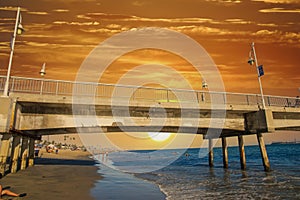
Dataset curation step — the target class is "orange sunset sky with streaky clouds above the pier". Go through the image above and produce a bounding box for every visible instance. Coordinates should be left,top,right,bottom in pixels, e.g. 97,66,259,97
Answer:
0,0,300,96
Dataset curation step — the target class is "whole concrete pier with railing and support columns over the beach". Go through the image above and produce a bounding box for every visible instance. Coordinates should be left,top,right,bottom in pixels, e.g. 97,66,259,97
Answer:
0,76,300,175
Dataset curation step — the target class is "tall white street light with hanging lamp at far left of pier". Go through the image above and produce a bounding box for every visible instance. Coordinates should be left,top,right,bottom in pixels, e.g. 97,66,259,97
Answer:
3,7,24,97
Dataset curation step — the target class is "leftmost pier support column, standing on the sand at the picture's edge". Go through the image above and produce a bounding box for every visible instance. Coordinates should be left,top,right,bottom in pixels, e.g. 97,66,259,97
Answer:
0,134,11,176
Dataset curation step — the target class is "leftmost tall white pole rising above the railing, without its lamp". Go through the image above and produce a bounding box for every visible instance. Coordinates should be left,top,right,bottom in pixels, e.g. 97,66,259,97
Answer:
3,7,20,97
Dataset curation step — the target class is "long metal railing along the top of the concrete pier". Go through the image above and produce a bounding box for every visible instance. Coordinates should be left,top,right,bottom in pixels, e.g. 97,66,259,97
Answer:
0,76,300,107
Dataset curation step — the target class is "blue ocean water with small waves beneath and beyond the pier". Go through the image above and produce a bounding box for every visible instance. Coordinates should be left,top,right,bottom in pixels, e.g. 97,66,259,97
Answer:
92,144,300,200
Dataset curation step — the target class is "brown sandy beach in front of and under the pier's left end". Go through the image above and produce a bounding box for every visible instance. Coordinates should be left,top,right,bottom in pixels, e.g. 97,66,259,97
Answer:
1,150,101,200
